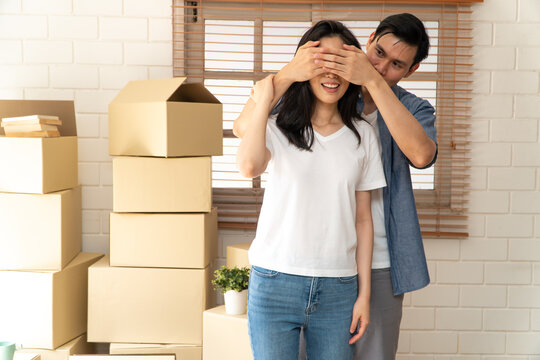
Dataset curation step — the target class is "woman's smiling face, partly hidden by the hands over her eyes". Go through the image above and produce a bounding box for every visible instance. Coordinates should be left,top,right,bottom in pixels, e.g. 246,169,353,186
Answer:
309,36,349,104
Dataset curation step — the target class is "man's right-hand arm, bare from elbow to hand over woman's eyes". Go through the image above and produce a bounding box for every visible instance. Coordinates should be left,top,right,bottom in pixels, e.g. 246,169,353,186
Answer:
315,45,437,168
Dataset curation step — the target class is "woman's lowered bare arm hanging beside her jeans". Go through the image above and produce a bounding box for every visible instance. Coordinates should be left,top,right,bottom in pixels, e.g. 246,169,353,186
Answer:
349,191,373,344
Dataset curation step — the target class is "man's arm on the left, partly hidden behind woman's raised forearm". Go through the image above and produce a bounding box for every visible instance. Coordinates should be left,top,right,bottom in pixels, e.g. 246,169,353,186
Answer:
233,41,323,138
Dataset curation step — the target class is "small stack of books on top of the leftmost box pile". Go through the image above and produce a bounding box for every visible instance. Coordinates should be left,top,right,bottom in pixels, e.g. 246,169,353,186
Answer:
2,115,62,137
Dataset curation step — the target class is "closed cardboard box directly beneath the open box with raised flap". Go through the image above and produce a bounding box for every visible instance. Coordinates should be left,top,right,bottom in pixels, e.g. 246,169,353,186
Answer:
113,157,212,212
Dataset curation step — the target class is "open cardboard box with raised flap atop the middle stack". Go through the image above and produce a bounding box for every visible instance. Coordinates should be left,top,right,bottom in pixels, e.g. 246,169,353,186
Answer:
109,77,223,157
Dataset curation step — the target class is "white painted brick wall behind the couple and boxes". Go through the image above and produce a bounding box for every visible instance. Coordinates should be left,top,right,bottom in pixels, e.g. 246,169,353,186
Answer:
0,0,540,360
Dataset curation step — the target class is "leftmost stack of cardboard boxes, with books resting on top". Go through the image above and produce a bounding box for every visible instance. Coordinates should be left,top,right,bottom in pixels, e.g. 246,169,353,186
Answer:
0,100,102,352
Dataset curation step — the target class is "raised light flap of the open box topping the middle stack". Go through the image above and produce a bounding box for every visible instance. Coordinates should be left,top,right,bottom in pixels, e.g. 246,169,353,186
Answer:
111,77,186,104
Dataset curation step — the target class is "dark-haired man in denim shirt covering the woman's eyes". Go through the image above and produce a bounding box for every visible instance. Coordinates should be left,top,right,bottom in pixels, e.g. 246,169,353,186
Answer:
234,14,437,360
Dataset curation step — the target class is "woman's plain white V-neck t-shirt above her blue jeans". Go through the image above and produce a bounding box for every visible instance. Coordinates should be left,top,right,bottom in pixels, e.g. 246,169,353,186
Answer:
249,116,386,277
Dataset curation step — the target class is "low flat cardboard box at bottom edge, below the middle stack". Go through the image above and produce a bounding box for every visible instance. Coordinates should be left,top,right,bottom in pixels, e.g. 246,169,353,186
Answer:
109,343,202,360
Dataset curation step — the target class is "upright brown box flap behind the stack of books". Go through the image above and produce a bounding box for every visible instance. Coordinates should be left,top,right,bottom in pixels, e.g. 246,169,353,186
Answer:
0,100,77,136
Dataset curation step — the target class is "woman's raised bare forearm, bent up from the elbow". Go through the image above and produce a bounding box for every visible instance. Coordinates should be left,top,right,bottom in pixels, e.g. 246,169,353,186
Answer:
236,75,274,178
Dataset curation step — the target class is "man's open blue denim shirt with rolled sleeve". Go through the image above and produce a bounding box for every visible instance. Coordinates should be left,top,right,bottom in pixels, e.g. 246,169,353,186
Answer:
358,85,437,295
